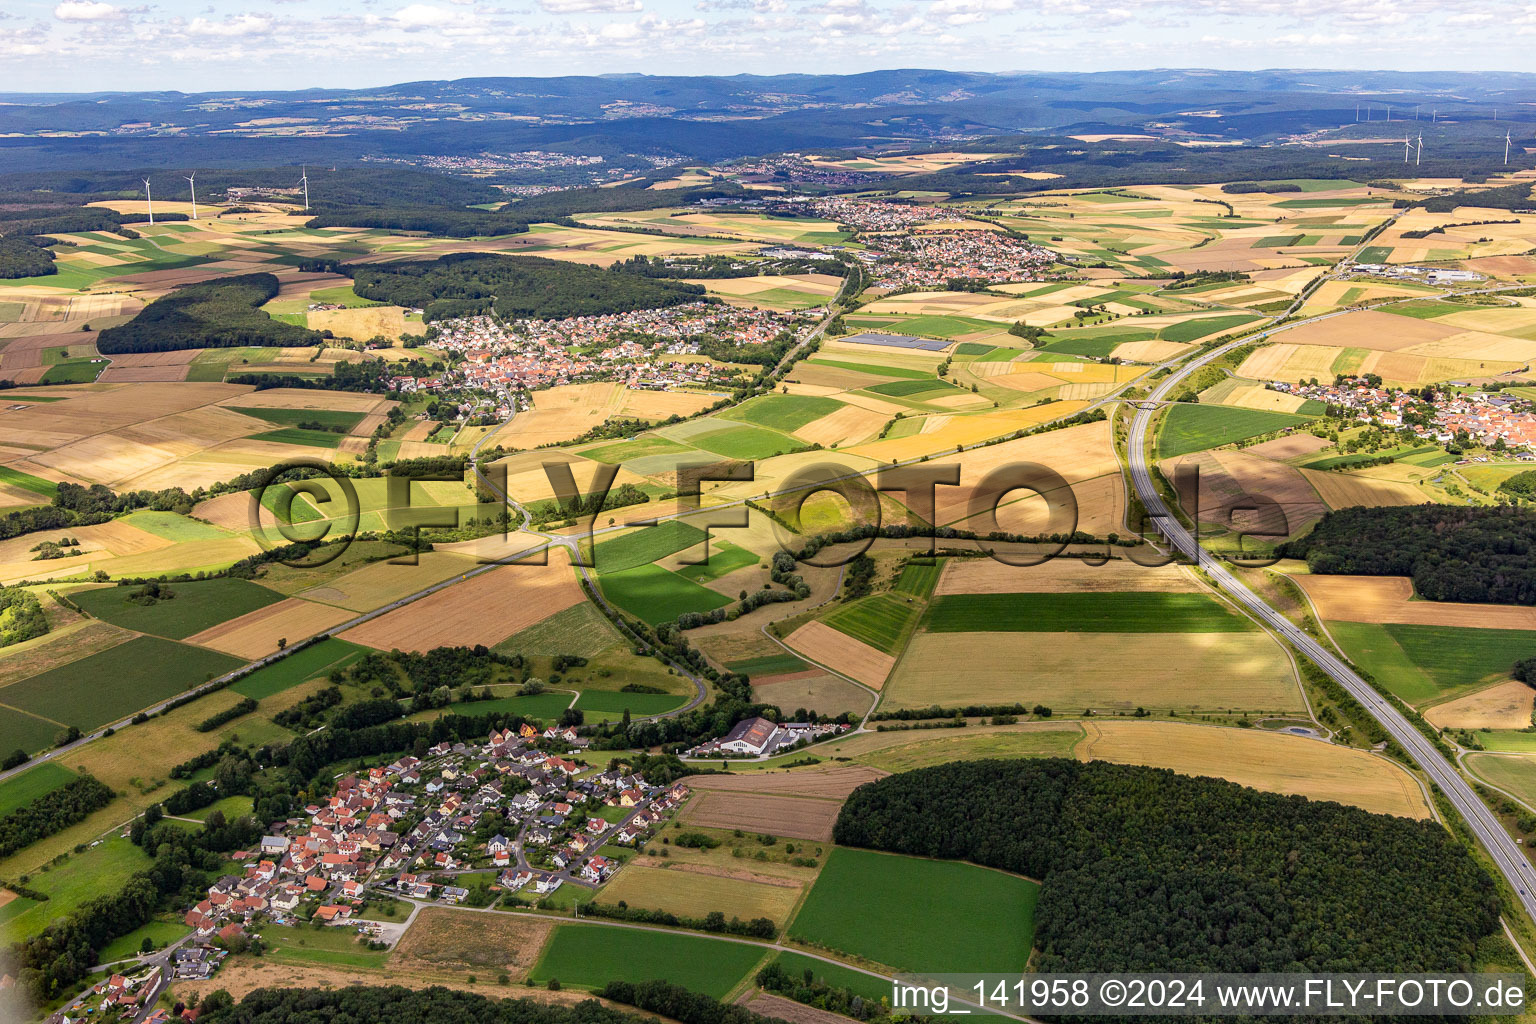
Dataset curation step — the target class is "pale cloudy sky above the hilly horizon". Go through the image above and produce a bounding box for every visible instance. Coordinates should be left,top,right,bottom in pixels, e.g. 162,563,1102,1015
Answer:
0,0,1536,92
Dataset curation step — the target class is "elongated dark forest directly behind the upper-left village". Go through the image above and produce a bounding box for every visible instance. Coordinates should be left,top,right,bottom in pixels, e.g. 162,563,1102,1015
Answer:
353,252,703,321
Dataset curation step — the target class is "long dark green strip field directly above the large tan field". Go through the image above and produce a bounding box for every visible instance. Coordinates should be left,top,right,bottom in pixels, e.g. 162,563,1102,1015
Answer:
923,591,1256,633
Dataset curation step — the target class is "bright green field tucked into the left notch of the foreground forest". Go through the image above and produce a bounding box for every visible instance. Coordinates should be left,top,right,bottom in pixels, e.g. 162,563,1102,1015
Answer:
790,847,1040,973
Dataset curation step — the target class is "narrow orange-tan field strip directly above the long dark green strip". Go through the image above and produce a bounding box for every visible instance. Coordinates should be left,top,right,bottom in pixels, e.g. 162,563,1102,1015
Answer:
934,557,1200,596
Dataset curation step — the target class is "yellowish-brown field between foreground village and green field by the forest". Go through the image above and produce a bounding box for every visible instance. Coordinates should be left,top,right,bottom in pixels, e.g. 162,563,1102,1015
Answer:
598,857,803,924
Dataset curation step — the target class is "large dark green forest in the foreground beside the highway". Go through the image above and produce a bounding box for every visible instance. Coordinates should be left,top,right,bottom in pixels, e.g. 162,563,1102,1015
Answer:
833,758,1499,972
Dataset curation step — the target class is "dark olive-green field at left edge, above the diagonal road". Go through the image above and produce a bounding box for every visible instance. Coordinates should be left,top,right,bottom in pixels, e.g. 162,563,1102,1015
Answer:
5,637,243,733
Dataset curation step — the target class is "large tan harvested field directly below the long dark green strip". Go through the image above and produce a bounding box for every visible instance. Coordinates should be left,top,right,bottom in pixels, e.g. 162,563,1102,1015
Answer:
882,633,1306,714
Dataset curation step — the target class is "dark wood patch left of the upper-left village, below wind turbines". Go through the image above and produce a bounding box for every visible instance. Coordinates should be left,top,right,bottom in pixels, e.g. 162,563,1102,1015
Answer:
97,273,324,356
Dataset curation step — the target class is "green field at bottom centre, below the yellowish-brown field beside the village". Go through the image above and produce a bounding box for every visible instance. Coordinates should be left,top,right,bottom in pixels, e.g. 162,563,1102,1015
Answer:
528,924,768,999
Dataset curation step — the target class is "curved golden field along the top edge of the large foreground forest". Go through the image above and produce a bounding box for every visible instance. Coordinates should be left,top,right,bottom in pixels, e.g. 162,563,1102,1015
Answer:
1077,722,1430,818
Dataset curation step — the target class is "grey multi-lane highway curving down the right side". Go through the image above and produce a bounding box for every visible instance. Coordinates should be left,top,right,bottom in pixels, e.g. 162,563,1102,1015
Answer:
1126,313,1536,918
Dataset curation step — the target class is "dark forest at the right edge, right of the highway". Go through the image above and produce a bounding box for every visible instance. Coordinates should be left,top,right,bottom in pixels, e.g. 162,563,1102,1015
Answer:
1276,505,1536,605
